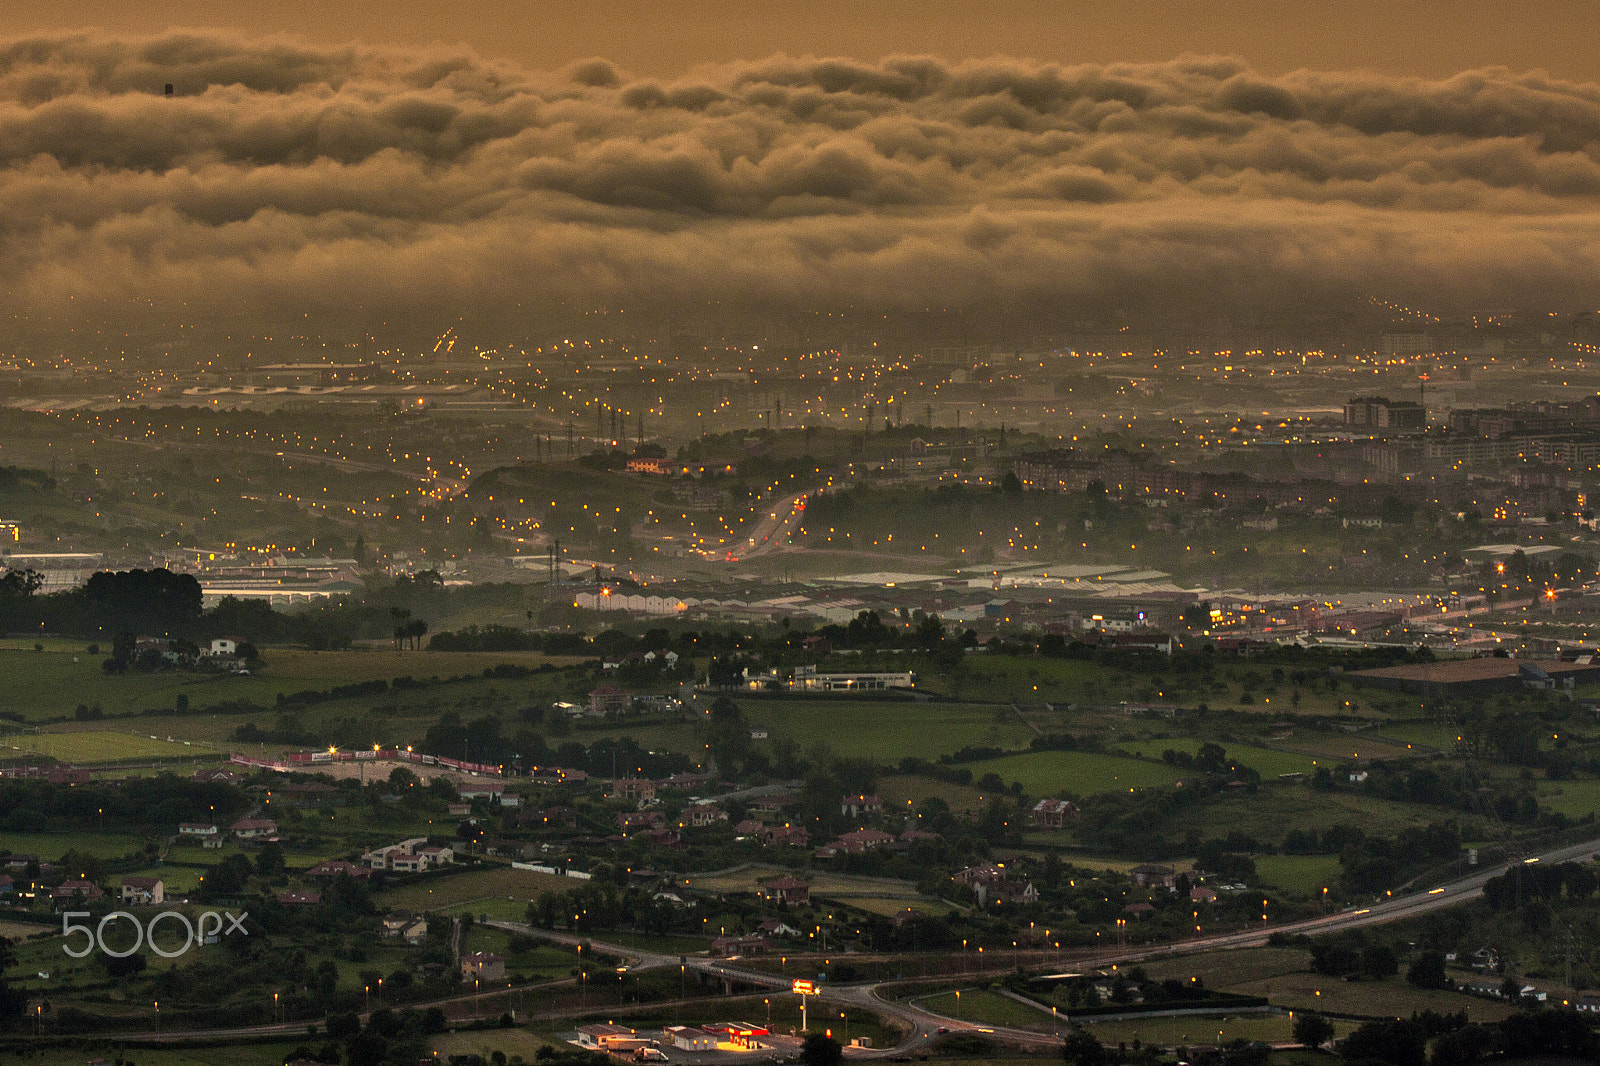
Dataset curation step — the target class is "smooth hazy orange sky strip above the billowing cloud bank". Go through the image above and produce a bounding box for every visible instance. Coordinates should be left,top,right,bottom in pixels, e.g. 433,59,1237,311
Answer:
0,0,1600,82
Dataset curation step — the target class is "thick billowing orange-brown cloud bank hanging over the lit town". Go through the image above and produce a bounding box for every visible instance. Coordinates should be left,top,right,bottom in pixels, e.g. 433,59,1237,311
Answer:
0,34,1600,320
